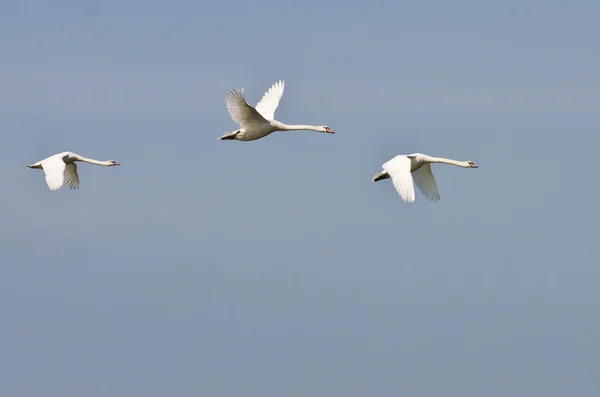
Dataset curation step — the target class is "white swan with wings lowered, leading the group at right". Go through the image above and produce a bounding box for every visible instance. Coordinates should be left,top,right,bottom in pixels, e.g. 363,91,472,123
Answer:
373,153,479,203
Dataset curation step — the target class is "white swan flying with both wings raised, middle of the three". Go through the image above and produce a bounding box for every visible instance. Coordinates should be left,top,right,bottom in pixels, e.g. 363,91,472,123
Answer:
217,80,335,141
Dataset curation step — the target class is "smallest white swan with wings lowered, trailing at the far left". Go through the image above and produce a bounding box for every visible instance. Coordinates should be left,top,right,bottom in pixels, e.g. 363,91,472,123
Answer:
27,152,121,191
